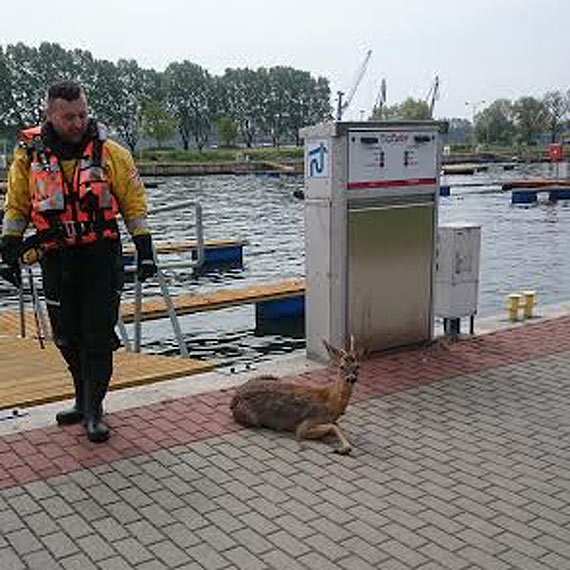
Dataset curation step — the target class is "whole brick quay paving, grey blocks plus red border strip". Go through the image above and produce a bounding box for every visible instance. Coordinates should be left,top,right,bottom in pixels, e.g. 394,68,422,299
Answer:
0,317,570,570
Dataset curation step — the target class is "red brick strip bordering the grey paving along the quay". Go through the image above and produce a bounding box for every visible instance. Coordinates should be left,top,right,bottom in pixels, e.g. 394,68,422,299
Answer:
0,317,570,489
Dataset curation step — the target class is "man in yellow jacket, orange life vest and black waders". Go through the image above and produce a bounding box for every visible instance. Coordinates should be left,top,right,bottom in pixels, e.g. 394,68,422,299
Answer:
0,81,156,442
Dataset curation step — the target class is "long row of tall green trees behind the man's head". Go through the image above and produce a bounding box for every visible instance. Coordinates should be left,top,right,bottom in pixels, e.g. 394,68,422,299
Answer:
0,42,330,151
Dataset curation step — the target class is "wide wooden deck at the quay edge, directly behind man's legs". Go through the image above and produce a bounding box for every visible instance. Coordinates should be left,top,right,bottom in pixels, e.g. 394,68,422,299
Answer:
0,336,214,409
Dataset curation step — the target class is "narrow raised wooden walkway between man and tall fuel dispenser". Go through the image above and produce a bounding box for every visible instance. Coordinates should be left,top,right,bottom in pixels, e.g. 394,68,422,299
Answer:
121,279,305,323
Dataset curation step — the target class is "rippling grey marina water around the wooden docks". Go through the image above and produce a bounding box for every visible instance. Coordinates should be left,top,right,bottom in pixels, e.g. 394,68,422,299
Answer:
0,165,570,372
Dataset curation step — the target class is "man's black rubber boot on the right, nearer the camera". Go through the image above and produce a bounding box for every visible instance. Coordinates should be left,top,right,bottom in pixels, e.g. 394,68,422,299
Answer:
82,351,113,443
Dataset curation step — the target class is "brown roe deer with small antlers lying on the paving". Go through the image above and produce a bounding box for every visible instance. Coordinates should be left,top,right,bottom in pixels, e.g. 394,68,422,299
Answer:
230,338,358,455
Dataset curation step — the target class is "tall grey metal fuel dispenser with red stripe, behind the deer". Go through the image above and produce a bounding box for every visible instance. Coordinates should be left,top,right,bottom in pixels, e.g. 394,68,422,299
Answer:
301,121,440,360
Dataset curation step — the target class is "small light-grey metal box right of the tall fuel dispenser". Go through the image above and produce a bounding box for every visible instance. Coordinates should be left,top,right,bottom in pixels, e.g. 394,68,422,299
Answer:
434,223,481,319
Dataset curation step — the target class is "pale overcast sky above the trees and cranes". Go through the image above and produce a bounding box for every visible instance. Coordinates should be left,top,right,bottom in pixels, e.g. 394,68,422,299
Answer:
0,0,570,119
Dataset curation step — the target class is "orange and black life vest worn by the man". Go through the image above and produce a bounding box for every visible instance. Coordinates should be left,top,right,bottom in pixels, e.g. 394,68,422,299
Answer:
20,127,119,250
